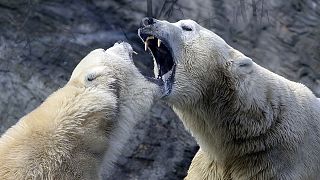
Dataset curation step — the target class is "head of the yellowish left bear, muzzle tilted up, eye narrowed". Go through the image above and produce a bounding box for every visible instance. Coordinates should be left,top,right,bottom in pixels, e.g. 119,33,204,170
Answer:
66,42,159,129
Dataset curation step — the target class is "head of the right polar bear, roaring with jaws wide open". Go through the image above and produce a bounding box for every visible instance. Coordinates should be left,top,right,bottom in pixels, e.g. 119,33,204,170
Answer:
138,18,252,105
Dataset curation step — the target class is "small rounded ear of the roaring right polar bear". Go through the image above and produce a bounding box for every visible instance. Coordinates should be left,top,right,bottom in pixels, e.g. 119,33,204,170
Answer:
231,56,253,74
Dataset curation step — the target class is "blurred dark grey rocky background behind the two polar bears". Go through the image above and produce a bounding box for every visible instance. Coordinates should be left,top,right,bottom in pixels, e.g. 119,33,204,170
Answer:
0,0,320,180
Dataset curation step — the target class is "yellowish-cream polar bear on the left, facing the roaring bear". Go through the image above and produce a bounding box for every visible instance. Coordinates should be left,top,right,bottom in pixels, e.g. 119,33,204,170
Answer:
0,42,158,180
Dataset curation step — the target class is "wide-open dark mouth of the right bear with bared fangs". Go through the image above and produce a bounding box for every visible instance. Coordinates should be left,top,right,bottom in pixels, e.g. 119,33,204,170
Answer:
139,33,176,95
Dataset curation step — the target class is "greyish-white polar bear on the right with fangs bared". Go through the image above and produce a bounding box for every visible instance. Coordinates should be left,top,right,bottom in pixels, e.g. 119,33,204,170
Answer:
138,18,320,180
